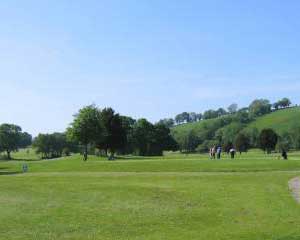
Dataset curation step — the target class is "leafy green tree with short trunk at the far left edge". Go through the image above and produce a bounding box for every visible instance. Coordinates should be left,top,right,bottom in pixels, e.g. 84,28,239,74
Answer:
0,123,22,159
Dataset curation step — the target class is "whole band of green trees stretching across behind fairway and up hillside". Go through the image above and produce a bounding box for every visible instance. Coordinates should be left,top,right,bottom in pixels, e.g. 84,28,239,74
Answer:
0,98,300,160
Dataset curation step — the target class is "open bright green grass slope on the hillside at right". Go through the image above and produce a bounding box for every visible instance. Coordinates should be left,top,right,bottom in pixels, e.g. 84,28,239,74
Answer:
247,107,300,134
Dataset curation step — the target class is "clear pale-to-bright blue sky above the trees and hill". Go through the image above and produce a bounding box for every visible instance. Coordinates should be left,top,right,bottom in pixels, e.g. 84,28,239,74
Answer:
0,0,300,135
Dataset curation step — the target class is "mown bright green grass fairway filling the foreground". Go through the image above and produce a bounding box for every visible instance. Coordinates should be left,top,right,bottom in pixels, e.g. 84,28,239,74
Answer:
0,152,300,240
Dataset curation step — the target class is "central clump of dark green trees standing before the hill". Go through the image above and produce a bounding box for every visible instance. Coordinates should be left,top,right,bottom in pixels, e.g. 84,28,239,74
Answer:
40,105,177,161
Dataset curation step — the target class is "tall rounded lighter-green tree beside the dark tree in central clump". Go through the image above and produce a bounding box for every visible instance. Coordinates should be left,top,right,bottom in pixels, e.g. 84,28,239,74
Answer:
67,105,103,161
